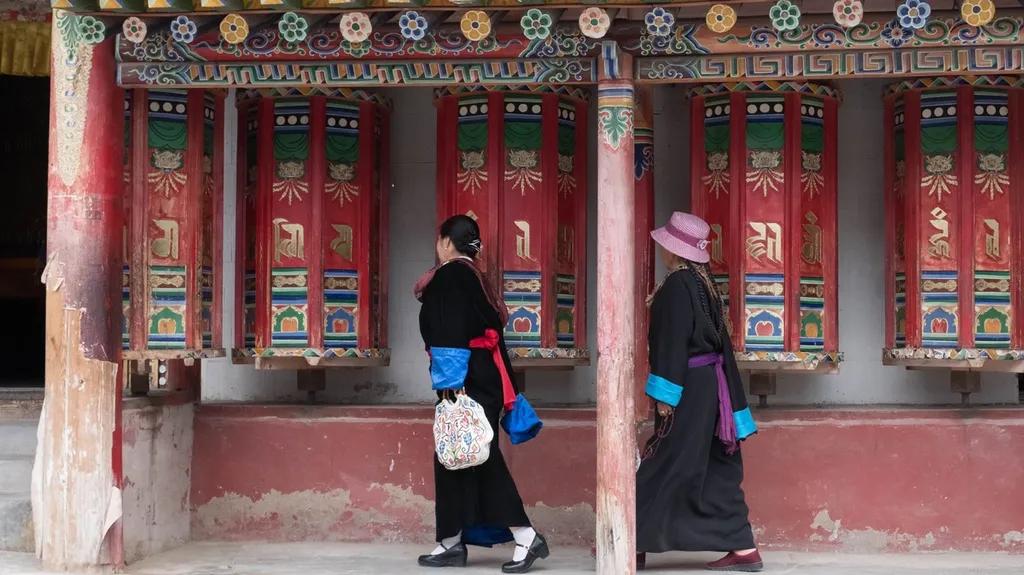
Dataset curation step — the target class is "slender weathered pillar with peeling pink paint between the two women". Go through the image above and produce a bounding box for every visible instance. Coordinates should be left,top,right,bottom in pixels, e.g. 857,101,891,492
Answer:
597,42,636,575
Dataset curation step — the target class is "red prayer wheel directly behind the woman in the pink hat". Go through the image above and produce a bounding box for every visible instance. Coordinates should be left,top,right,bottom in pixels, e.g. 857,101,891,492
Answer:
690,82,842,372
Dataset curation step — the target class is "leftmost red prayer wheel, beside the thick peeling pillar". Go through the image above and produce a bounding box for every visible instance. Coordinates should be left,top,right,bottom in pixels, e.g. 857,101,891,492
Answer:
122,90,224,360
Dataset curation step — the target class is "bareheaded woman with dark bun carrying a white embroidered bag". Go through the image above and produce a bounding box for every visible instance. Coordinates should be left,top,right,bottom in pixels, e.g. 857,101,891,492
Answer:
416,216,549,573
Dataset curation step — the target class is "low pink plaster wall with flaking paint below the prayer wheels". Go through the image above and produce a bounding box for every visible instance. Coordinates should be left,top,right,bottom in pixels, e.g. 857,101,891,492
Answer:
191,405,1024,552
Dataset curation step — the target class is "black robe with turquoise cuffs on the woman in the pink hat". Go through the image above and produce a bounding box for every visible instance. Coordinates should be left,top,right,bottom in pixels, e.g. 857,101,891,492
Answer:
637,268,756,552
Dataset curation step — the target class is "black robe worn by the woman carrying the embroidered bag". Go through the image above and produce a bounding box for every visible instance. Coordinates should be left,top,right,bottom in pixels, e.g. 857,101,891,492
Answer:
420,262,530,545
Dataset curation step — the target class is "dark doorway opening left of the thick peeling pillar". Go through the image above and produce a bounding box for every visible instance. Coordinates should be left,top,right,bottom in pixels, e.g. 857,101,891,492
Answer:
0,76,50,388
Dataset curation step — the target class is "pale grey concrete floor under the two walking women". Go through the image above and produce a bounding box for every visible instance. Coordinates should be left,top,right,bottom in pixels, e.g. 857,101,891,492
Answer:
0,543,1024,575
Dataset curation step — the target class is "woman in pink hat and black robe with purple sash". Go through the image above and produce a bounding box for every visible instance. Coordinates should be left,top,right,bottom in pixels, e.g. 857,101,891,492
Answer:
637,212,763,571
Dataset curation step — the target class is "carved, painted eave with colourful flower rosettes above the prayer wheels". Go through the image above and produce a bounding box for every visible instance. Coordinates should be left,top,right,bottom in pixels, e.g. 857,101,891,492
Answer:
53,0,1024,87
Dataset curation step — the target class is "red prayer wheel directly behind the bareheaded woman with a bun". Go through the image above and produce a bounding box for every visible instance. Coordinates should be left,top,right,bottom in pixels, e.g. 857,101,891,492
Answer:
436,88,589,366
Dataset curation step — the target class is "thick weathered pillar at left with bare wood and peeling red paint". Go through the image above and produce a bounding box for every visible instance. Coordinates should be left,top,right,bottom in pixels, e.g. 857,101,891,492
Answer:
33,10,124,570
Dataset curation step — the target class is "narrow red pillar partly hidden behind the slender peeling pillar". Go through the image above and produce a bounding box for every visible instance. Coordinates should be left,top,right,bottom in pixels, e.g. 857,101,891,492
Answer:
633,86,654,422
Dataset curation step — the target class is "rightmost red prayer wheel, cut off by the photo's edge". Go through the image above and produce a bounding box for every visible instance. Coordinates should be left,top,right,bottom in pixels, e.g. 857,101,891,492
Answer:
884,77,1024,371
